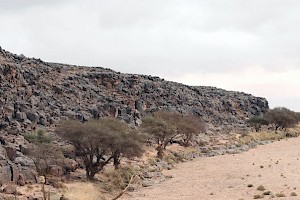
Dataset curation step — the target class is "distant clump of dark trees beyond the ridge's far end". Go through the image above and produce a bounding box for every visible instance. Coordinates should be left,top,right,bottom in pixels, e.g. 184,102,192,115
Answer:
247,107,300,132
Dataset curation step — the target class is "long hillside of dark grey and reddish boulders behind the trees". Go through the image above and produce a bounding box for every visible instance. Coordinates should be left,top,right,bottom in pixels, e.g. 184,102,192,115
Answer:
0,47,268,186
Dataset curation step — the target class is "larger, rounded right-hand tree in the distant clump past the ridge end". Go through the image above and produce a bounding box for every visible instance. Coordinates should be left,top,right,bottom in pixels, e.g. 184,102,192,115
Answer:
265,107,298,131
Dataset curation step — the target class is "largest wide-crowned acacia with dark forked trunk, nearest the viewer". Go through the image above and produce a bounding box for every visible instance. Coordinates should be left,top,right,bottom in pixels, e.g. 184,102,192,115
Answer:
57,117,142,180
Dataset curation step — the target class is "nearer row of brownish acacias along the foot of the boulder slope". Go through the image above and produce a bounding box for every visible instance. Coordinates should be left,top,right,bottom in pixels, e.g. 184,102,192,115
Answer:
25,111,205,180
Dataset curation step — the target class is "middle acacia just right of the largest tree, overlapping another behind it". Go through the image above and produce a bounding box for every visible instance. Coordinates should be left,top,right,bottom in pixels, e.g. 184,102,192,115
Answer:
142,115,177,159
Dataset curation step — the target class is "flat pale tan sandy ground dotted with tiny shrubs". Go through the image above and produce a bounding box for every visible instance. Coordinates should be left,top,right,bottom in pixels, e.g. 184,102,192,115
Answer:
120,137,300,200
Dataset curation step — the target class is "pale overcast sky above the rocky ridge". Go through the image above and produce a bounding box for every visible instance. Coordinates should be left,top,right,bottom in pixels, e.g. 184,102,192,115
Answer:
0,0,300,111
